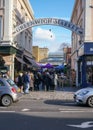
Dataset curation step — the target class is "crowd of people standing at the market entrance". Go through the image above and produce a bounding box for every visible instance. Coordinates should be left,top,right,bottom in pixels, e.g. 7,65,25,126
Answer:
15,70,58,93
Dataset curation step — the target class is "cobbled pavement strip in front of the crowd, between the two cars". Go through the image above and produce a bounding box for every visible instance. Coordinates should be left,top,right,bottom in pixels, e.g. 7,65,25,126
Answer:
25,87,79,100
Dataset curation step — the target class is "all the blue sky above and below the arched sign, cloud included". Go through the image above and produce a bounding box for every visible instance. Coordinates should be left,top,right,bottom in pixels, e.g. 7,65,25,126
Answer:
30,0,75,52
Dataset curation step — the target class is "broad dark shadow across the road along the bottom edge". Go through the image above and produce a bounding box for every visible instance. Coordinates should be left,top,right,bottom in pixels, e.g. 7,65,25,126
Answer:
0,113,93,130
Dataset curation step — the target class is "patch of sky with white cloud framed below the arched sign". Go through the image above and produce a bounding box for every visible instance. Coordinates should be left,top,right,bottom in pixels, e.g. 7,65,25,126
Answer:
33,27,70,52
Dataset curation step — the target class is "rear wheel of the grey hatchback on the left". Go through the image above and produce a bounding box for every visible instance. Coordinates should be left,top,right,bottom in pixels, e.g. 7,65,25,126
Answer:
1,95,13,106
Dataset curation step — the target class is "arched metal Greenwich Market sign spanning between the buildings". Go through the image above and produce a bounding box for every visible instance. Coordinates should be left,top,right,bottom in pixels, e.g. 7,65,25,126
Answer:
13,18,83,36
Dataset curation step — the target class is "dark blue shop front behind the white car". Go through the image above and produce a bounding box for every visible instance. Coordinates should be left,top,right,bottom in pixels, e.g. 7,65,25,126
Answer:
78,42,93,87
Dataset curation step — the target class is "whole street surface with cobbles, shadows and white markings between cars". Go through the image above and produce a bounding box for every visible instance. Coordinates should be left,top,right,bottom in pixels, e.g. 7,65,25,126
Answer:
0,88,93,130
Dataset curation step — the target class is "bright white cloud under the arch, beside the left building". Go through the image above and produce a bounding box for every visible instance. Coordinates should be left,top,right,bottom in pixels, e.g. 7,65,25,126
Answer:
34,28,55,41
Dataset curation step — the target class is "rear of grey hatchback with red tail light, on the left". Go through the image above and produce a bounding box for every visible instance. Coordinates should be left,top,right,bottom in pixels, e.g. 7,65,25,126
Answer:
0,78,22,106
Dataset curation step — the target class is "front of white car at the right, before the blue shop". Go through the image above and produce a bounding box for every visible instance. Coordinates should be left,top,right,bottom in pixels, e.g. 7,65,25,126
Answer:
74,87,93,107
